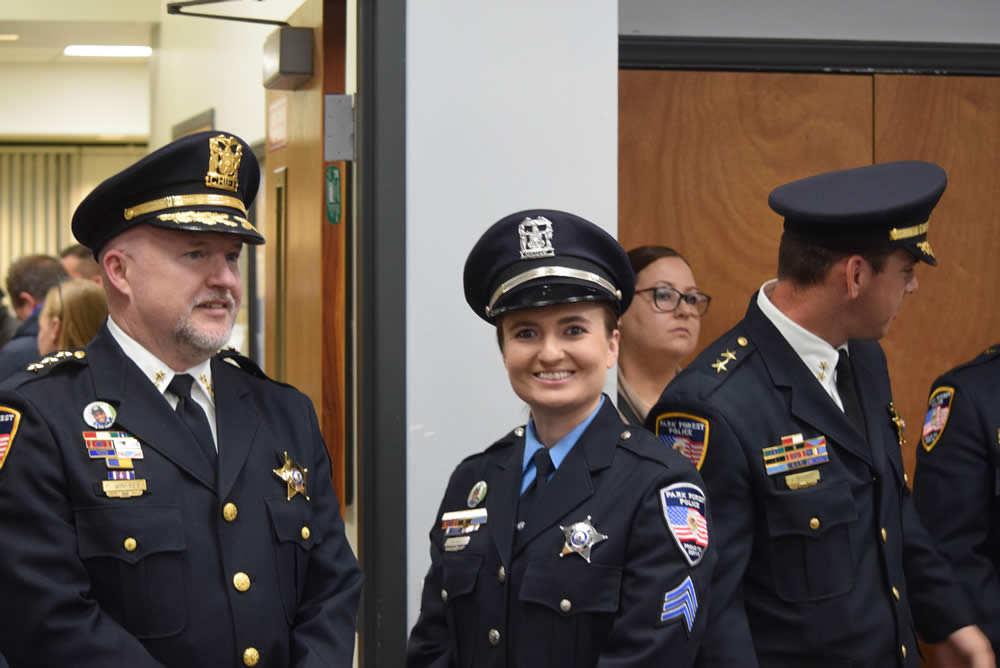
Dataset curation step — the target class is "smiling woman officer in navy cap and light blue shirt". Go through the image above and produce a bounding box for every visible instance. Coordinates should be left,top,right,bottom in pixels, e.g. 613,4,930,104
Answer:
407,210,716,668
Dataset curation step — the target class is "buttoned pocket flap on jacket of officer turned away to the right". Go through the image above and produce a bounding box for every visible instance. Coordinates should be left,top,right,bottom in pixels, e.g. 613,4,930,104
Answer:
766,485,858,536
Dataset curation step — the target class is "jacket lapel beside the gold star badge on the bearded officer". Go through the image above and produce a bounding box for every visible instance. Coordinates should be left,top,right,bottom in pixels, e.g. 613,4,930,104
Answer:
212,358,260,498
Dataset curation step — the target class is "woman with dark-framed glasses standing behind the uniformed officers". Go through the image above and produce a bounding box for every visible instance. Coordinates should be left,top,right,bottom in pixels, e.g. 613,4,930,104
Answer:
618,246,712,425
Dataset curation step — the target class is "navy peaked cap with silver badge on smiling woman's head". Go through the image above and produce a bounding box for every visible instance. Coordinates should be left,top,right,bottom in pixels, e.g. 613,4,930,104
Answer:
464,209,635,323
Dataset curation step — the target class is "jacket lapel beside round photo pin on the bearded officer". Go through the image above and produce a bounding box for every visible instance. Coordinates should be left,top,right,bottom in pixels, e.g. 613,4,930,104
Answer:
87,324,215,490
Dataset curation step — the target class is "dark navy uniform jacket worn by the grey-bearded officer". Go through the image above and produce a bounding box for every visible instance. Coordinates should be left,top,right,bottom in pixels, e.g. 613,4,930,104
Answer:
0,327,361,668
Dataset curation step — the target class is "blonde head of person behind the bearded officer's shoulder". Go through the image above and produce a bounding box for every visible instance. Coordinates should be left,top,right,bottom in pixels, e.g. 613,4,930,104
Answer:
38,278,108,356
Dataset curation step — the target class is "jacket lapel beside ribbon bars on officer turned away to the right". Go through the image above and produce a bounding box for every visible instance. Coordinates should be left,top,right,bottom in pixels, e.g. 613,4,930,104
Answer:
744,302,872,464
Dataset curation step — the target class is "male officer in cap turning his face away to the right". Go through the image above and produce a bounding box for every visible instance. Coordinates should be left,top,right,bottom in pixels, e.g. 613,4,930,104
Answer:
647,162,993,668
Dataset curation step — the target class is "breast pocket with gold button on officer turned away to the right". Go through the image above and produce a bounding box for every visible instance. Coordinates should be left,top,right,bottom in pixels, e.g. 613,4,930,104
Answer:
766,485,858,603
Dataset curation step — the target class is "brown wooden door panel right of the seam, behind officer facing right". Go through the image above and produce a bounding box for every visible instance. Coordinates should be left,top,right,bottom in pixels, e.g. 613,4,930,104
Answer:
874,75,1000,480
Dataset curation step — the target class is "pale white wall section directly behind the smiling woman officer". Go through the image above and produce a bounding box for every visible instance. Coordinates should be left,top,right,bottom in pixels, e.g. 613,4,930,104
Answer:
406,0,618,625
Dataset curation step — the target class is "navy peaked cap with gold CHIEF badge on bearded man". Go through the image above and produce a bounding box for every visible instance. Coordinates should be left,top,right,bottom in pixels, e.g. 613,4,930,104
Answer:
73,130,264,257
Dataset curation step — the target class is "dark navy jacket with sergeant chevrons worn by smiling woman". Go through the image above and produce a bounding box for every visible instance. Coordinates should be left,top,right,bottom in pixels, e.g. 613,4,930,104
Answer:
407,398,716,668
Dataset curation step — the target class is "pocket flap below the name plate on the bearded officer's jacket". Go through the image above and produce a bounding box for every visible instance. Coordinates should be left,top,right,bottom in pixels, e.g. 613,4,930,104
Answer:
74,505,187,564
